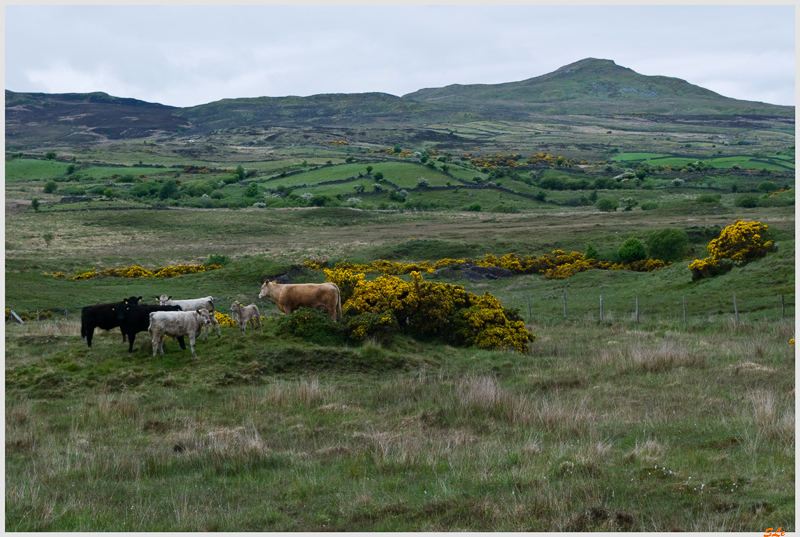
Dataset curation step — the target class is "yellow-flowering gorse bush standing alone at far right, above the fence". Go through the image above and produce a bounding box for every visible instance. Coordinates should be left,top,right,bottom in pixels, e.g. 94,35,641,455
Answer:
688,220,776,280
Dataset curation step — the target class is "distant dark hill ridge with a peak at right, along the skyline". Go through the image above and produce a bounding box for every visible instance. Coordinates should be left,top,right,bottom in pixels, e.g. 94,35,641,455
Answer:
6,58,795,147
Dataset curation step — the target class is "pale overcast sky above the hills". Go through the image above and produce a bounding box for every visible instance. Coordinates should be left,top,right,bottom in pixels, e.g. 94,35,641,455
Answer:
5,4,795,107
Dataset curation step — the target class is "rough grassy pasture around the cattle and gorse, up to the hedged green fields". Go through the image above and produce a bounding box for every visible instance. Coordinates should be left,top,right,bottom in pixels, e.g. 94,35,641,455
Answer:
5,136,795,532
